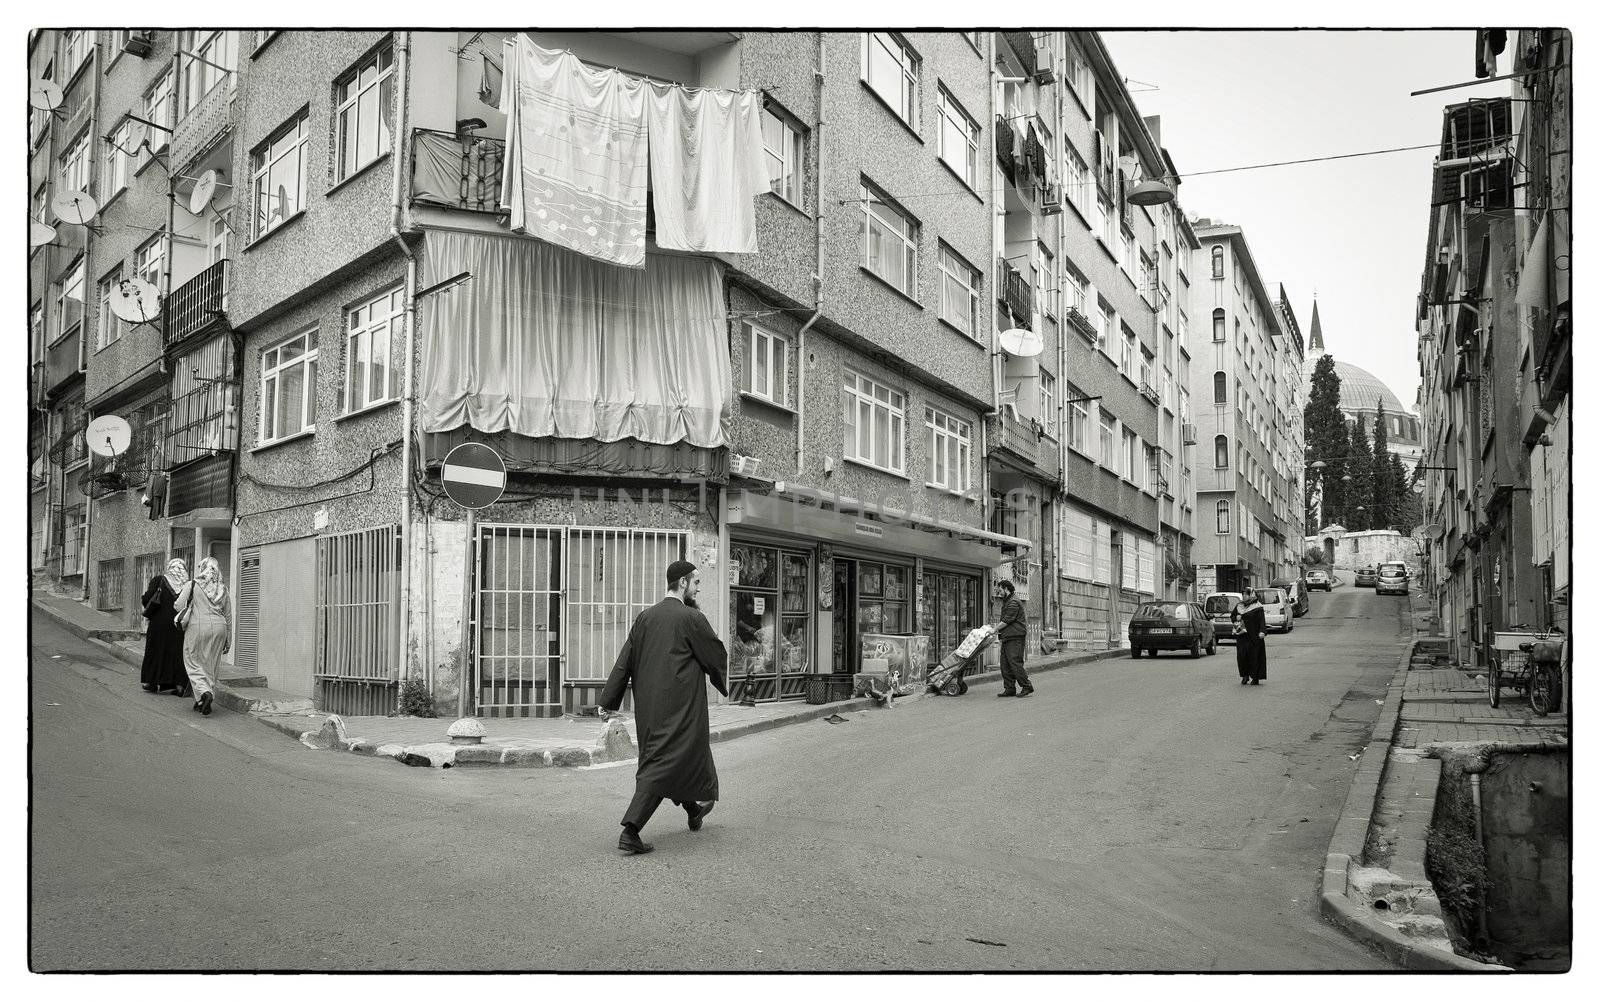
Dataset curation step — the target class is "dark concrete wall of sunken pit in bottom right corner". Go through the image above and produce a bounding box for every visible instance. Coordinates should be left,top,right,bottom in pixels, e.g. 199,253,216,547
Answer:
1482,751,1573,965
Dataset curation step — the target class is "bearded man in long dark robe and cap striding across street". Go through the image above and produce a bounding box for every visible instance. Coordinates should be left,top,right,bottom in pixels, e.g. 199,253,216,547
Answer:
600,560,728,855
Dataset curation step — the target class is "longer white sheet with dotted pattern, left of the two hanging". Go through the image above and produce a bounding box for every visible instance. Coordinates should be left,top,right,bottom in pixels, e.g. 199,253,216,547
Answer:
499,34,650,267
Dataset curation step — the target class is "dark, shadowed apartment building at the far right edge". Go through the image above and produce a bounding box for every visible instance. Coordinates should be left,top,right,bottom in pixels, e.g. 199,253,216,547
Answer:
1418,29,1571,664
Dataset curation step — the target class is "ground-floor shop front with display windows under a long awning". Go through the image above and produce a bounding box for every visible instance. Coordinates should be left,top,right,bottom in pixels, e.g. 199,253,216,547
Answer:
726,493,1024,701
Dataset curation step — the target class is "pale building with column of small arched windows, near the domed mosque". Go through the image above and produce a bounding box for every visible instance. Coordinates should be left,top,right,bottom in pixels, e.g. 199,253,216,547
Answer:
1190,219,1299,595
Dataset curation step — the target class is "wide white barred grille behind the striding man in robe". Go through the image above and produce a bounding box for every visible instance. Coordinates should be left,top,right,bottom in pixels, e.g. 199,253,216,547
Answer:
474,525,688,717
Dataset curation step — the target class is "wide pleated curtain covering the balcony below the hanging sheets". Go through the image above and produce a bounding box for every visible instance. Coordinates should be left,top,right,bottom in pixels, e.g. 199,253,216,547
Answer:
421,230,733,448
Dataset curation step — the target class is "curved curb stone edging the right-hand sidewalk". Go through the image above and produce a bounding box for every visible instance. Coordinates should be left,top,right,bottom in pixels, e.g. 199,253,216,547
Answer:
1320,624,1510,972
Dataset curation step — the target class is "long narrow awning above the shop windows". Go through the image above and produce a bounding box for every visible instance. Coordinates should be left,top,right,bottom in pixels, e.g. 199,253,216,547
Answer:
728,482,1030,567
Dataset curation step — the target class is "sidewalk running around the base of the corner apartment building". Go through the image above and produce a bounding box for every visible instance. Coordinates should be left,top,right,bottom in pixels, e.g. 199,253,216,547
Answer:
34,597,1128,768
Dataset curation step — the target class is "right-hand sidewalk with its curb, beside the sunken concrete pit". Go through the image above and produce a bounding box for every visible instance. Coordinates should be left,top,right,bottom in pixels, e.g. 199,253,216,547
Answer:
1322,595,1570,972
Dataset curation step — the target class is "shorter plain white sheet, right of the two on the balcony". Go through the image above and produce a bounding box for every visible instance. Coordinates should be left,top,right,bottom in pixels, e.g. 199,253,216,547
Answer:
646,85,771,255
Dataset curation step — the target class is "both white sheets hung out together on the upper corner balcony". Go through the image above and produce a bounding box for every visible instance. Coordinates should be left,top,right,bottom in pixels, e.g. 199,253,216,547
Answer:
499,35,770,267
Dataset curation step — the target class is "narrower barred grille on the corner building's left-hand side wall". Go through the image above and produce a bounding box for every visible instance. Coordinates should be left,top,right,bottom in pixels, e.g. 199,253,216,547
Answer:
314,525,400,715
